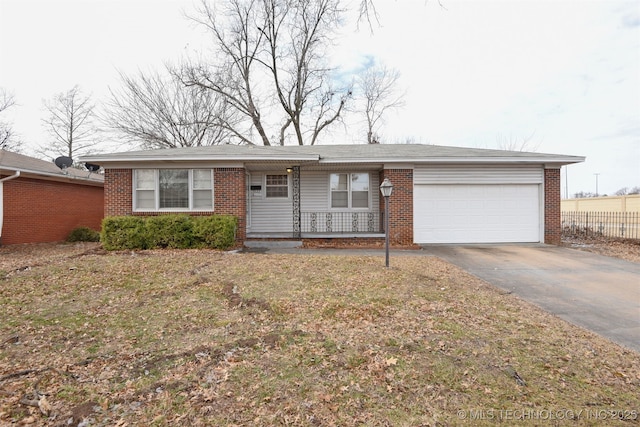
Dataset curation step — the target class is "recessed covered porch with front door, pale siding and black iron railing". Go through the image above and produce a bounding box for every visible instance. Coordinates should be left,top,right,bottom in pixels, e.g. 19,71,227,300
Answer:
246,163,385,239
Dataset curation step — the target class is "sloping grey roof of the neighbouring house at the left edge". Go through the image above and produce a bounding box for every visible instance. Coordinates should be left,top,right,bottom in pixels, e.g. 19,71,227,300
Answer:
0,150,104,185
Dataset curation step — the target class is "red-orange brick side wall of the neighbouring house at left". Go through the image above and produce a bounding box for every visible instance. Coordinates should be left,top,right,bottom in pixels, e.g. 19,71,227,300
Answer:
0,177,104,245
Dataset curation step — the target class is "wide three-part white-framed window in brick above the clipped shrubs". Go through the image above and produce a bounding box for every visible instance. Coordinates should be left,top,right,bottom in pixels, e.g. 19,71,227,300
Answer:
134,169,213,211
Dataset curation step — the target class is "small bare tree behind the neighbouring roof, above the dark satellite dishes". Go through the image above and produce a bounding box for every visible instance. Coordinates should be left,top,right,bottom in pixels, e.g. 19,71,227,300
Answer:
38,85,99,163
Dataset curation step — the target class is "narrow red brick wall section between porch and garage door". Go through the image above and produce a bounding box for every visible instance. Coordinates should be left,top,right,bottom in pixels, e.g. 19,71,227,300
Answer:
378,169,413,246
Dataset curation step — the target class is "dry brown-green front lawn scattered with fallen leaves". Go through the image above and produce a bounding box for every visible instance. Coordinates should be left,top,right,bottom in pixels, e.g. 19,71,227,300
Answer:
0,244,640,426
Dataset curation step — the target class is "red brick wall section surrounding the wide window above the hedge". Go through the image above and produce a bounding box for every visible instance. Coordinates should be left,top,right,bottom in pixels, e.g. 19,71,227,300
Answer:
104,168,247,242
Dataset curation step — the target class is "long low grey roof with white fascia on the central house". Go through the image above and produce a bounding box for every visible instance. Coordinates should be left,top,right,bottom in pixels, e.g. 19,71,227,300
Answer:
80,144,585,166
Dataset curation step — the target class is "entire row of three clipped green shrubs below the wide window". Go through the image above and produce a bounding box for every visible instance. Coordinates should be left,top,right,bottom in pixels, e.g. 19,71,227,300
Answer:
101,214,238,250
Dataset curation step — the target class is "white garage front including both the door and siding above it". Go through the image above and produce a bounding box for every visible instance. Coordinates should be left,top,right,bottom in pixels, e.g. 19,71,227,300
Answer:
413,165,544,243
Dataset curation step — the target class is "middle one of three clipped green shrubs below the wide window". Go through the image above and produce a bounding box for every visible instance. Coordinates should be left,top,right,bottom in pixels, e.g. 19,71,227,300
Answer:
145,215,193,249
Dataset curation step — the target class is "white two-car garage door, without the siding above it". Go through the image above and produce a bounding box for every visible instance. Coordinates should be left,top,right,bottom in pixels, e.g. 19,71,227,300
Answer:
413,184,540,243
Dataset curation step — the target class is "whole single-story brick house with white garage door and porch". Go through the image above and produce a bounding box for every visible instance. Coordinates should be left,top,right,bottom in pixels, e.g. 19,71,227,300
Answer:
80,144,584,247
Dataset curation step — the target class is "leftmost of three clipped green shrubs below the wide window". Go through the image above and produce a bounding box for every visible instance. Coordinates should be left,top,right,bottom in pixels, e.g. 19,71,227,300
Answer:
101,216,149,251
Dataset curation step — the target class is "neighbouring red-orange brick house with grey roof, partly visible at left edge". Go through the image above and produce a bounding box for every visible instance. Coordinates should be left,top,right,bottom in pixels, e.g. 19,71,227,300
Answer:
0,150,104,245
